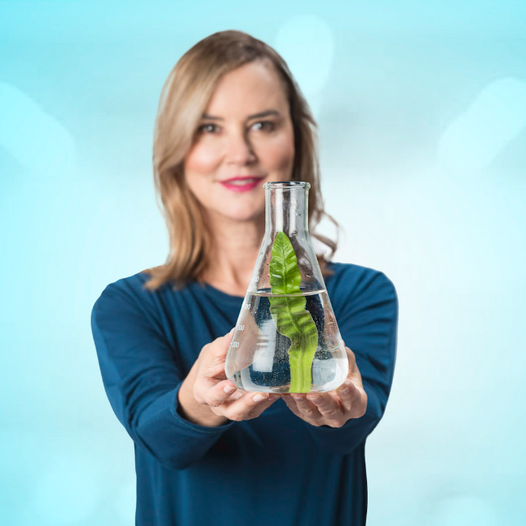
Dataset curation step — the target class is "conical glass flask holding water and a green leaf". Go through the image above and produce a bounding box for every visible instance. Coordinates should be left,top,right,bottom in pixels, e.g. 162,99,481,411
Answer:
225,181,349,393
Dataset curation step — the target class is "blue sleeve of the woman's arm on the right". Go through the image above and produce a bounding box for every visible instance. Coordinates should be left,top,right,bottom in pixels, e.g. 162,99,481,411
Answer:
309,271,398,455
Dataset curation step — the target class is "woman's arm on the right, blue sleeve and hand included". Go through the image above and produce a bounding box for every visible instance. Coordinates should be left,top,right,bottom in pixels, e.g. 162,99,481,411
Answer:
285,271,398,454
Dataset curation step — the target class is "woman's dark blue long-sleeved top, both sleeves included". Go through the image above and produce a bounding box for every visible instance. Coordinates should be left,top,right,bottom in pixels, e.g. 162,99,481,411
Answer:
91,263,398,526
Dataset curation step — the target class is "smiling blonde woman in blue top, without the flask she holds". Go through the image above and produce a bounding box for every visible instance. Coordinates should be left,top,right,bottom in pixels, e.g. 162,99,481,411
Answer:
92,31,398,526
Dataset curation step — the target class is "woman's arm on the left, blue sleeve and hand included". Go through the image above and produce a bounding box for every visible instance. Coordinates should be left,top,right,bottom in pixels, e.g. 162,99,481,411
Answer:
91,282,273,469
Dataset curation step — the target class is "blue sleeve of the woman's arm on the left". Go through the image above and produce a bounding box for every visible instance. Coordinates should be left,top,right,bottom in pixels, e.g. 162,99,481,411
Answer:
91,282,233,470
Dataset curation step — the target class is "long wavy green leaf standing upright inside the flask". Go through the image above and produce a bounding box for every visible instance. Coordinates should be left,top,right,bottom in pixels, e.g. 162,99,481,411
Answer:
269,232,318,393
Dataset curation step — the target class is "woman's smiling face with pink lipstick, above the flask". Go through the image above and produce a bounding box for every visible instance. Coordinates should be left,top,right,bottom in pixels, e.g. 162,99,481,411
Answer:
184,61,294,225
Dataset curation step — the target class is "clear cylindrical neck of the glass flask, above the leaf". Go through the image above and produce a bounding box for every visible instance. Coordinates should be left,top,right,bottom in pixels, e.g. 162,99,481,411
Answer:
265,181,310,237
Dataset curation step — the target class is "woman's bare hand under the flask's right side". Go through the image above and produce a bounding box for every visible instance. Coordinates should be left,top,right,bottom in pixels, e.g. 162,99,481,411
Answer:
283,347,367,427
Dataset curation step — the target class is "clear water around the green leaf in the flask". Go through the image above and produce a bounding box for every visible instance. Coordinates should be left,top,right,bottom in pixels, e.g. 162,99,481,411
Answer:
226,290,349,393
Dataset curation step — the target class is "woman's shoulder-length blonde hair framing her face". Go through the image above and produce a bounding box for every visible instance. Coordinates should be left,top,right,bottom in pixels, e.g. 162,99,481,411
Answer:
144,31,340,290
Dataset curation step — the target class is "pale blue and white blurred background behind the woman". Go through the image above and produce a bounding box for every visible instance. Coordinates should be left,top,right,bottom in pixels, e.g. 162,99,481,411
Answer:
0,0,526,526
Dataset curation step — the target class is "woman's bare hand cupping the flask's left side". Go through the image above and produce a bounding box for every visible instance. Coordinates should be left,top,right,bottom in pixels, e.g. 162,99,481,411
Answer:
179,330,280,427
